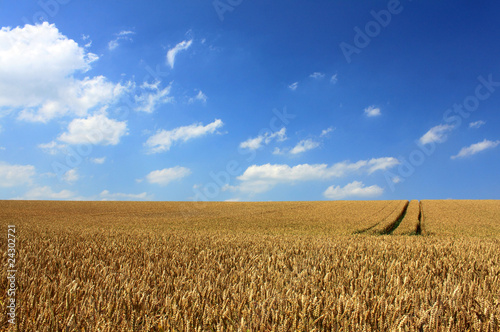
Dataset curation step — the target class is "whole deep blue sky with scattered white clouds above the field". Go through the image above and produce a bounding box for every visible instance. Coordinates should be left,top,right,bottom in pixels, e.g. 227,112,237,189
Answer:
0,0,500,201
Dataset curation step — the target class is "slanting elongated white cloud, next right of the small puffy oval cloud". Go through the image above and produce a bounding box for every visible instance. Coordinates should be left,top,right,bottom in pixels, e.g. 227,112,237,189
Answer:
144,119,224,153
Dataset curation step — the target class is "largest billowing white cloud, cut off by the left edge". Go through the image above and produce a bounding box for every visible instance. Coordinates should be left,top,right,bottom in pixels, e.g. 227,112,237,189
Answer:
0,22,127,123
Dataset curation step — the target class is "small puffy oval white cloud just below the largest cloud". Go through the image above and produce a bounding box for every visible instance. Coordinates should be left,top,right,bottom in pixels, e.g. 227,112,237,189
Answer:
59,114,127,145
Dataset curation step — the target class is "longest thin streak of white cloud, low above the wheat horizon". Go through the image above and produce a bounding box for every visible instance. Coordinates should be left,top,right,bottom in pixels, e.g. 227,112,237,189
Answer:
234,157,399,194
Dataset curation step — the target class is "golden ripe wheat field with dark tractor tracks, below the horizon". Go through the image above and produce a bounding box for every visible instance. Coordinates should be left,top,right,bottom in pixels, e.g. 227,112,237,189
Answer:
0,201,500,331
